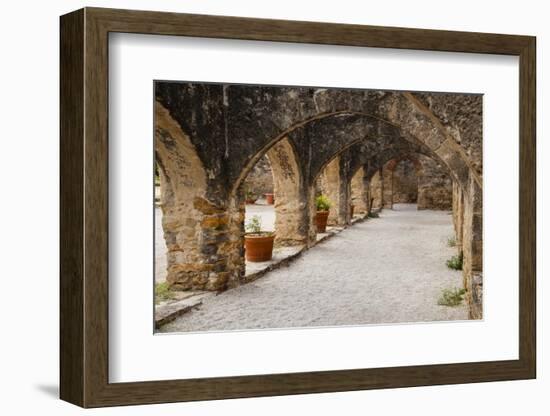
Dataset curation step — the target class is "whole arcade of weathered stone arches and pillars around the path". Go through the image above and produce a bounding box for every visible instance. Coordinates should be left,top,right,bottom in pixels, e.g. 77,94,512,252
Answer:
155,82,482,319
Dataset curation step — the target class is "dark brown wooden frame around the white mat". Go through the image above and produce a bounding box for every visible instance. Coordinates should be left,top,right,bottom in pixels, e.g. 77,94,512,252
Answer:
60,8,536,407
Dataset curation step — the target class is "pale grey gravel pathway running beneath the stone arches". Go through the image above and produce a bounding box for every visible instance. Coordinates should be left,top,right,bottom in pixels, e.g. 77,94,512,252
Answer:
161,204,468,332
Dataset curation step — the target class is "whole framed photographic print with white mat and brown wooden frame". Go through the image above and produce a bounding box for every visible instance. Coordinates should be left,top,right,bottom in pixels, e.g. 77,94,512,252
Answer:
60,8,536,407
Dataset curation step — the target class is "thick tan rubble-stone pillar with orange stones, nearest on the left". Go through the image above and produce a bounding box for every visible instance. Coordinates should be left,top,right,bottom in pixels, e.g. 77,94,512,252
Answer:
155,103,244,290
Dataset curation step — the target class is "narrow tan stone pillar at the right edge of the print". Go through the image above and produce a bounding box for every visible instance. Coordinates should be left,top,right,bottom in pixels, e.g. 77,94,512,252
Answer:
462,177,483,319
